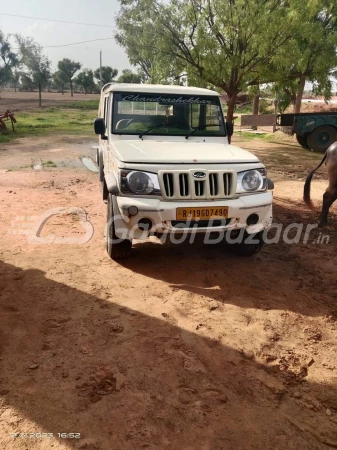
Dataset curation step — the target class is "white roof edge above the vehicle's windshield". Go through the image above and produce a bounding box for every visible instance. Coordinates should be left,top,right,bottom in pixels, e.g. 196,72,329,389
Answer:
102,83,220,97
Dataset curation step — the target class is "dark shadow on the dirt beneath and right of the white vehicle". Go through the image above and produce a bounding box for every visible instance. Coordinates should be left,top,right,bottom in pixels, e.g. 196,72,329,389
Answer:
121,201,337,316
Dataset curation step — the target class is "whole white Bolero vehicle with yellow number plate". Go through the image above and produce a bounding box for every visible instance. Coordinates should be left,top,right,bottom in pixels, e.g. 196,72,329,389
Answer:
95,84,273,259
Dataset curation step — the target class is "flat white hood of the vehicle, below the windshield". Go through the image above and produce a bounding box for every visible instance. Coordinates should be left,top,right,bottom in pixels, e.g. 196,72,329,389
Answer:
113,140,259,164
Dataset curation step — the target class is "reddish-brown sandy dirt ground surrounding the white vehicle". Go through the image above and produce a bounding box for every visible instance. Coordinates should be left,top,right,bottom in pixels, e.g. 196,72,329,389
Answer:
0,136,337,450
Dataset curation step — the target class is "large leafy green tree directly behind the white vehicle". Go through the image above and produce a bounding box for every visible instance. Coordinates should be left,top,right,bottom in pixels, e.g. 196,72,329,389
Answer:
116,0,336,120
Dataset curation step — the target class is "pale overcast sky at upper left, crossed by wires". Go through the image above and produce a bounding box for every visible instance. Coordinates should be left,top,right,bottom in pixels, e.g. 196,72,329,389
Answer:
0,0,130,73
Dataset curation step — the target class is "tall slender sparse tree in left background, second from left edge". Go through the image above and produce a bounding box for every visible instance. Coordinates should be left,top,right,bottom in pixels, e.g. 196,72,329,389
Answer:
17,35,52,107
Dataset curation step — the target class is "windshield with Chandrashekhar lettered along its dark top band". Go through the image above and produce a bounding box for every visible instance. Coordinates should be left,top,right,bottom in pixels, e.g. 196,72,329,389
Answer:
112,93,226,137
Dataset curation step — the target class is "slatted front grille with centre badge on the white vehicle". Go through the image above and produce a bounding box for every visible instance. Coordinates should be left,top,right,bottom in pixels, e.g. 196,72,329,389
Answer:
158,169,236,200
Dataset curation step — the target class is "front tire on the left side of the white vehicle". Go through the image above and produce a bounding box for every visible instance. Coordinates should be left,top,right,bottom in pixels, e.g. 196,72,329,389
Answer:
106,194,132,259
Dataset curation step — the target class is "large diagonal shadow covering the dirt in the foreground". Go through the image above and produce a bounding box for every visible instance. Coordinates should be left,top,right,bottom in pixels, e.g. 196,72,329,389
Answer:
0,258,337,450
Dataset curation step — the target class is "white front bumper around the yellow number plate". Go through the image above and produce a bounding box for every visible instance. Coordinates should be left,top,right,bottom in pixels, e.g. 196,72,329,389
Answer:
114,191,273,239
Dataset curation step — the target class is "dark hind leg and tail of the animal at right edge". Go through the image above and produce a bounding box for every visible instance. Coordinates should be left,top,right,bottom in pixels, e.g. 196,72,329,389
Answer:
303,142,337,226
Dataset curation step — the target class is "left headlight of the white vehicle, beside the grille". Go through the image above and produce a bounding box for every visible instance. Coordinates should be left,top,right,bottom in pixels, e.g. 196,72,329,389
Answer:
120,170,161,195
